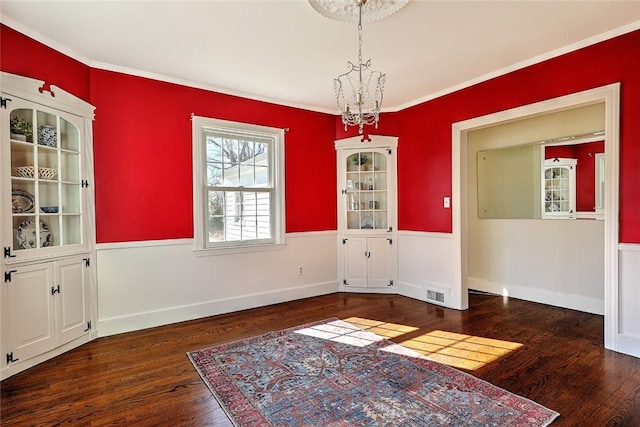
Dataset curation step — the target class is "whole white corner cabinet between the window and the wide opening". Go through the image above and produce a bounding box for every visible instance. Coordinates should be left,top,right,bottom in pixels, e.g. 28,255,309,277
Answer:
335,135,398,293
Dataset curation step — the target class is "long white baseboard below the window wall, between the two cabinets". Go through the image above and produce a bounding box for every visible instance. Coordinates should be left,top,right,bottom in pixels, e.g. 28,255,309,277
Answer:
97,282,338,337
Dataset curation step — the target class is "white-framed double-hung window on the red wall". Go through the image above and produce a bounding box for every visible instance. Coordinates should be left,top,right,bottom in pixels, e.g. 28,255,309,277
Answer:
192,116,284,250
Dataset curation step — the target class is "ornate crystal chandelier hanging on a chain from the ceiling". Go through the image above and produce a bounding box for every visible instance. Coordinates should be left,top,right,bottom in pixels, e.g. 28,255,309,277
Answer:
333,0,385,134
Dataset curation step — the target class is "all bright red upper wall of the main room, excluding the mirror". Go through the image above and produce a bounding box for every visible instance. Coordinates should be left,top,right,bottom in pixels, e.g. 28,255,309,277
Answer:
0,25,640,243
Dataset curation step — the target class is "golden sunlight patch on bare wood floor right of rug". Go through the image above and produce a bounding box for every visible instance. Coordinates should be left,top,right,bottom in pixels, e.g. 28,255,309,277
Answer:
401,330,522,371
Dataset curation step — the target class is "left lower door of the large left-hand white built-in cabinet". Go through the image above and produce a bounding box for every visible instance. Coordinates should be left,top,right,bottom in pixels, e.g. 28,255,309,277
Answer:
2,263,56,364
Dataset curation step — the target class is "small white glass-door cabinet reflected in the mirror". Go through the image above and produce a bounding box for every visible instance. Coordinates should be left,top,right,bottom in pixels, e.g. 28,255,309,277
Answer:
542,158,578,219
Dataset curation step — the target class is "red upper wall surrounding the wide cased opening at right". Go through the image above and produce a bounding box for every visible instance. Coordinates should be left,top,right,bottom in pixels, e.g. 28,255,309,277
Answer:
398,31,640,243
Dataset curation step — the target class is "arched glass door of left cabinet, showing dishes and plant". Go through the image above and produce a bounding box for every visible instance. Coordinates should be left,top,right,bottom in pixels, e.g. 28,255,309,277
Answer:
8,100,83,254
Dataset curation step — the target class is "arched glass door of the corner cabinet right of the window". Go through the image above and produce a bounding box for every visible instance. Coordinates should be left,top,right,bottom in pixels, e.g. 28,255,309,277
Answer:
344,150,389,231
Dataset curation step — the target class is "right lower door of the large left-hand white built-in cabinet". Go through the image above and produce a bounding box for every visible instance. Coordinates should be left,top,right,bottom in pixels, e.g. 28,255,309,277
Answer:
55,258,90,346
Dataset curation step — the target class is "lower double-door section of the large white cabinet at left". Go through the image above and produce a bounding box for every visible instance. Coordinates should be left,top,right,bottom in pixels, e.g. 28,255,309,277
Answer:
2,257,92,366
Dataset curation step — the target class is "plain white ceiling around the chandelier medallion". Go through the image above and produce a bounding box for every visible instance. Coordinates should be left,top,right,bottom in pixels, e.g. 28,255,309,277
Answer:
0,0,640,113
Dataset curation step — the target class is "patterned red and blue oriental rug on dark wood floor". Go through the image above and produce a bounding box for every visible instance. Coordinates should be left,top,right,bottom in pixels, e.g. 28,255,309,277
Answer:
188,319,558,427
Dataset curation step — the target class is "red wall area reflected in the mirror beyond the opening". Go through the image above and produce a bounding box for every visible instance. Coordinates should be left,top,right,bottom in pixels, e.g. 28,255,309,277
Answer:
544,141,604,212
